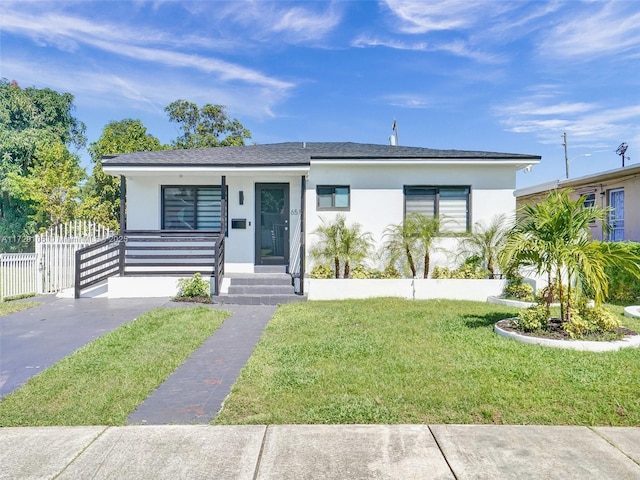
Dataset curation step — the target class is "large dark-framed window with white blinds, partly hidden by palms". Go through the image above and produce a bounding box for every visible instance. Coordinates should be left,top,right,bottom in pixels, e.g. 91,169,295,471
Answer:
404,185,471,233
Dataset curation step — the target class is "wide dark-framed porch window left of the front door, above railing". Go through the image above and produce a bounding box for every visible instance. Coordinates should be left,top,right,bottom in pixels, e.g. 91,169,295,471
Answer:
162,186,222,231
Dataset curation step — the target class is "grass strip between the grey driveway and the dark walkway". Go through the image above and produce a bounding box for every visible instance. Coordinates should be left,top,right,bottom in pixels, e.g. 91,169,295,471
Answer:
0,307,229,426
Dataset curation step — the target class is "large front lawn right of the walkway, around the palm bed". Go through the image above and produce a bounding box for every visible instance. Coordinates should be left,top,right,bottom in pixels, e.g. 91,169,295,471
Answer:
215,298,640,426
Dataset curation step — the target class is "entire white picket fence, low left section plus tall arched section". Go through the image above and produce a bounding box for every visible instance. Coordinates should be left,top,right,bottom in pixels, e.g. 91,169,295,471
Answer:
0,220,112,301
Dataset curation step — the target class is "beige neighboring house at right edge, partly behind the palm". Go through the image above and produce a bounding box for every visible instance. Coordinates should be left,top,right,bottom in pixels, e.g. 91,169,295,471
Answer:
514,164,640,242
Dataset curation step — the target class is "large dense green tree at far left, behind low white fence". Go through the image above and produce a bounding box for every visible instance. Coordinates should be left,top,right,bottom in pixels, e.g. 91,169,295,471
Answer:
0,79,86,251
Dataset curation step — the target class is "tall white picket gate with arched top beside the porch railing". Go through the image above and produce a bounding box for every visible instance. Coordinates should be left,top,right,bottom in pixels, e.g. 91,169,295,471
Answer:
36,220,111,293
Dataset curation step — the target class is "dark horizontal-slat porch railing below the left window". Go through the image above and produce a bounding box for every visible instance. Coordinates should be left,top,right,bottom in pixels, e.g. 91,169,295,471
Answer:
75,230,224,298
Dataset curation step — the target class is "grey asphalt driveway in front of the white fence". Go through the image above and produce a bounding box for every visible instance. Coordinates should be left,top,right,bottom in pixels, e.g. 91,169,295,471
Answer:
0,296,169,398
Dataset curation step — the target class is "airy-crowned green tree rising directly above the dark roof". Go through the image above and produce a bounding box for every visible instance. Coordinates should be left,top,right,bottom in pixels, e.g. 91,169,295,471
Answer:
165,99,251,149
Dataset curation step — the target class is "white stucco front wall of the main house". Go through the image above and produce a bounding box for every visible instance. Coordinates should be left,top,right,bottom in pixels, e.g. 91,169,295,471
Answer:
127,162,515,273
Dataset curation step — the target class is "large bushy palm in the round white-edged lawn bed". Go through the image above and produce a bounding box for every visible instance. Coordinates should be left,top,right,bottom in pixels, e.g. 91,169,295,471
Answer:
504,190,640,321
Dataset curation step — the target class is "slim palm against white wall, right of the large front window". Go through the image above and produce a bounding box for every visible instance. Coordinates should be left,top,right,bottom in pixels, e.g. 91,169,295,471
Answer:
461,214,511,278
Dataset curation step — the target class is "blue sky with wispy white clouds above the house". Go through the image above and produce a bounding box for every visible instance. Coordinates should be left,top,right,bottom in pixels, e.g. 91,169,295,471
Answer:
0,0,640,187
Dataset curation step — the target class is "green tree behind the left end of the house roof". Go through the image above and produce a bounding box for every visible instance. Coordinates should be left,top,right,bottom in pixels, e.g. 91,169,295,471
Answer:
78,119,168,231
